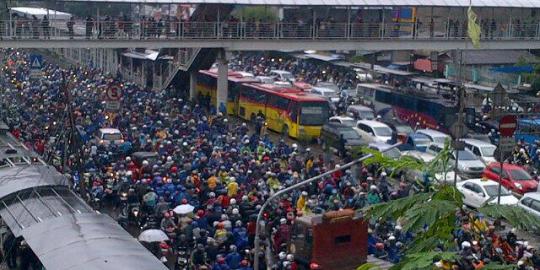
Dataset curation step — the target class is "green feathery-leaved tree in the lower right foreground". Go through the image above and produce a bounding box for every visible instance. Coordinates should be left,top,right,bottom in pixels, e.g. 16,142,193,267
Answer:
361,143,540,269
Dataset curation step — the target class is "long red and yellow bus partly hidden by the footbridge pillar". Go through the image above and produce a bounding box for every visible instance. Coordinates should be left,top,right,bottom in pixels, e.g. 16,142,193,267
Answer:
197,71,330,139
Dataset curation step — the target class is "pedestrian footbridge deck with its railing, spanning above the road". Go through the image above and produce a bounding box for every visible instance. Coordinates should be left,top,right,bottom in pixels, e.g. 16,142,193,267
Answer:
0,21,540,51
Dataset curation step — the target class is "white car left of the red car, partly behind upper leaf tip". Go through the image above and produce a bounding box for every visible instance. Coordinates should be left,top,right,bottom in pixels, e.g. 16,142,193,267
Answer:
426,143,486,179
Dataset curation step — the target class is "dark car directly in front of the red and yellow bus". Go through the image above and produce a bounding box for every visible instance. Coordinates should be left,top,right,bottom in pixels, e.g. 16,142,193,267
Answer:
321,123,368,156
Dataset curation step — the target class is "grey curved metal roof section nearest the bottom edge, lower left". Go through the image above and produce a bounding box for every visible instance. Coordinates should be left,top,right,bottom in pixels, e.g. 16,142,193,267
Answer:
22,213,167,270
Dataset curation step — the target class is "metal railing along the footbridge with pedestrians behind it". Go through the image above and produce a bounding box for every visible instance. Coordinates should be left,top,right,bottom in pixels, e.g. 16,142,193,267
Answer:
0,19,540,40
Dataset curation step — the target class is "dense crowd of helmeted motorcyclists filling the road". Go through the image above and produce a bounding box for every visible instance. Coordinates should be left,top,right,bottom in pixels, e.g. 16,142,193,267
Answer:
0,47,536,270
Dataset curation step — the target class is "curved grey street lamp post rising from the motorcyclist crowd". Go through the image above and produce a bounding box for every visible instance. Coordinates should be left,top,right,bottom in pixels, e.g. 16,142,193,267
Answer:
253,143,401,270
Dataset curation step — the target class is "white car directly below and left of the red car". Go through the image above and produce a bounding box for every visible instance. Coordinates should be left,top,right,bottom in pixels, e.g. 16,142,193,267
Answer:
457,179,519,208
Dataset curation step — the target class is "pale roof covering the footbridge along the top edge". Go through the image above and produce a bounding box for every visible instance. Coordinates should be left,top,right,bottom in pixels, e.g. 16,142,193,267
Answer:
58,0,540,8
